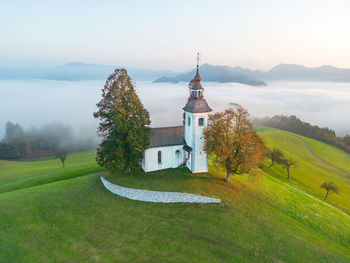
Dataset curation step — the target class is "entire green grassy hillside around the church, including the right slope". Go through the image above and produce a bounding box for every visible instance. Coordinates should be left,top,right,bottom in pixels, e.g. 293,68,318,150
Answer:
0,128,350,262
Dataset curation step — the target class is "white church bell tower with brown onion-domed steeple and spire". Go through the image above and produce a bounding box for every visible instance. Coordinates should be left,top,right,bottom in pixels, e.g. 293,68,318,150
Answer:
183,53,212,173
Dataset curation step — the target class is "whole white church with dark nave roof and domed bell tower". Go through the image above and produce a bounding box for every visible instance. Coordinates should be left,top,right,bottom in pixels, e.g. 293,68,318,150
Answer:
142,60,212,173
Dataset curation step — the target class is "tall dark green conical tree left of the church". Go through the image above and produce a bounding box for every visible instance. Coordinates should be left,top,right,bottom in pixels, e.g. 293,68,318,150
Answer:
94,69,151,172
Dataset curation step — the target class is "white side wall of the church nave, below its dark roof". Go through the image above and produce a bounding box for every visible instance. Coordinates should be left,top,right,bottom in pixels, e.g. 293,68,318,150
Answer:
142,145,185,172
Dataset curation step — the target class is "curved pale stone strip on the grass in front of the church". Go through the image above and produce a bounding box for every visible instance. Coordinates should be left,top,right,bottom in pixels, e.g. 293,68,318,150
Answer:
101,176,221,203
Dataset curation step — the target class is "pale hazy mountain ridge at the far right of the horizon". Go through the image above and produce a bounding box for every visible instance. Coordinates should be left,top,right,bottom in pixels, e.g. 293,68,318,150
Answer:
263,64,350,82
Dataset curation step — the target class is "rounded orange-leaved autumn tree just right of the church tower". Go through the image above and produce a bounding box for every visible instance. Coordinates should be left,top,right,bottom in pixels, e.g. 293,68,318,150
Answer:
203,106,266,182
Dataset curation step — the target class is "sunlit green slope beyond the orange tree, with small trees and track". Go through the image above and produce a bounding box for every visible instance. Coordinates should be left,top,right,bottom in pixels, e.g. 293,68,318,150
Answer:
256,127,350,216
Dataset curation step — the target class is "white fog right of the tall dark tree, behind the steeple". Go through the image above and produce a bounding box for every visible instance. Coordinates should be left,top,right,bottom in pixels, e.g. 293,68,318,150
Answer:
137,81,350,136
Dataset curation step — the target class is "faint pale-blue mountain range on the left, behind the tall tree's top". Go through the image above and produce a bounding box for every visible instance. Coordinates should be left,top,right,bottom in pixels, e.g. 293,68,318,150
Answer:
0,62,178,80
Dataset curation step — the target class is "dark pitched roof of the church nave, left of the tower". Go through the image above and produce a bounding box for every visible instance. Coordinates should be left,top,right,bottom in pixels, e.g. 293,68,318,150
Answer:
149,126,185,148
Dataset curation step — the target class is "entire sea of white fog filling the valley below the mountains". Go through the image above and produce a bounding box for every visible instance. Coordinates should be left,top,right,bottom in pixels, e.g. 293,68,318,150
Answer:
0,80,350,138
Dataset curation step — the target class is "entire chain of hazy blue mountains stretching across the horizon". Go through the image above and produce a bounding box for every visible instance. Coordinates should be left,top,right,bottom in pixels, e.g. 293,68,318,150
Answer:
0,62,350,83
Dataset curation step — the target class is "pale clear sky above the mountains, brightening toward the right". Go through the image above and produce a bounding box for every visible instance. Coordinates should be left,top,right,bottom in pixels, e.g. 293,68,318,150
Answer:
0,0,350,71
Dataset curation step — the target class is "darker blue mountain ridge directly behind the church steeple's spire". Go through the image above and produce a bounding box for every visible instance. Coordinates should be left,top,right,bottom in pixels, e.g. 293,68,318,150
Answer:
154,64,266,86
